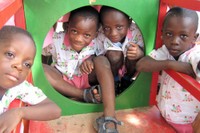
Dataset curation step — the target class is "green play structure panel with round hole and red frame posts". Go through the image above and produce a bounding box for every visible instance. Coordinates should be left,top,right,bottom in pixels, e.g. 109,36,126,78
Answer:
0,0,200,132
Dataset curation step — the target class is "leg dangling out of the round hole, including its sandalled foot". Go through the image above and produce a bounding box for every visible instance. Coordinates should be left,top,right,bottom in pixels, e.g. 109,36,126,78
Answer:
94,56,121,133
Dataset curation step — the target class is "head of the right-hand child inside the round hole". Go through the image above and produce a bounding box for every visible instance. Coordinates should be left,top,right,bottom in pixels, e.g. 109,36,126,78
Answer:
100,6,131,43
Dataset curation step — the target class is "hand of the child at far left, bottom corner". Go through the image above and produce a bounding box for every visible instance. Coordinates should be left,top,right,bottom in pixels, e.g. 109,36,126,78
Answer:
0,109,22,133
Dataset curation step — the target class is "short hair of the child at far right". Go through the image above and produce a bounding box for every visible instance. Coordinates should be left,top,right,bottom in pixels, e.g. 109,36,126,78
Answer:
163,7,199,30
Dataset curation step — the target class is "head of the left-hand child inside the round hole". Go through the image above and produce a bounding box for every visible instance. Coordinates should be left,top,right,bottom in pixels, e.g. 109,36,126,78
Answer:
67,6,99,52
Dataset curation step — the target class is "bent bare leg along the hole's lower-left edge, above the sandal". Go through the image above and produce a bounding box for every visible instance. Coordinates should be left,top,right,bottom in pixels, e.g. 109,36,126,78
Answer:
43,64,83,100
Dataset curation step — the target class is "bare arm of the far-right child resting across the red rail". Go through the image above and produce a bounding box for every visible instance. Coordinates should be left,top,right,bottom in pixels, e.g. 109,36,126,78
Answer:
136,56,195,77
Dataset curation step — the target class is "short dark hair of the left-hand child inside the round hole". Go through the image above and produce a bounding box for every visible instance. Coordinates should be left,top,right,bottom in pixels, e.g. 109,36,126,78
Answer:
69,6,99,28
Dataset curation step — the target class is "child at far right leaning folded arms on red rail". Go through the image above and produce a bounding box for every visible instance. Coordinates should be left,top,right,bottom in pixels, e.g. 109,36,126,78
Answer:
137,7,200,133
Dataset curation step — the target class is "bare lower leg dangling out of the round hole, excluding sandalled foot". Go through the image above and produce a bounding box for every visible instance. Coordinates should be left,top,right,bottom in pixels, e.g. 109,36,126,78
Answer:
94,56,115,117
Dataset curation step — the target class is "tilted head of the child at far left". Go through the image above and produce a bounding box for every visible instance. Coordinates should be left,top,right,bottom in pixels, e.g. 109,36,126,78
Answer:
0,26,36,91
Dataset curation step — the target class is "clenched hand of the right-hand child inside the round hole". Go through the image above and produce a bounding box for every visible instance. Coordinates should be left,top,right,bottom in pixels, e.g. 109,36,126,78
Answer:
126,42,144,60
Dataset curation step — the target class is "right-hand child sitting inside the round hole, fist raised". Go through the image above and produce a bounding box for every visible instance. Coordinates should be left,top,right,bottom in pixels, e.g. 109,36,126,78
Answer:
97,6,144,94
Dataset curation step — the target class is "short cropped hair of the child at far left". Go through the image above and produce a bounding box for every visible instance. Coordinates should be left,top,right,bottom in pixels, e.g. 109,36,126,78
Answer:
0,26,35,45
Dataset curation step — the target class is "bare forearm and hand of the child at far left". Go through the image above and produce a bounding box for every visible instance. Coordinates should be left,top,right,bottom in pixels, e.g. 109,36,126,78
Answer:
0,98,61,133
